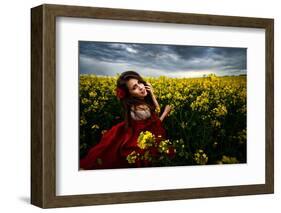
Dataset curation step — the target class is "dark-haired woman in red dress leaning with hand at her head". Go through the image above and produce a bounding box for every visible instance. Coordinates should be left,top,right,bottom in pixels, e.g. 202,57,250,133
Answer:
80,71,171,170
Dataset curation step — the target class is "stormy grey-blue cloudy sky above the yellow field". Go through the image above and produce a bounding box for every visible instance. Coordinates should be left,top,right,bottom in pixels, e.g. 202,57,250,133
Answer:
79,41,247,77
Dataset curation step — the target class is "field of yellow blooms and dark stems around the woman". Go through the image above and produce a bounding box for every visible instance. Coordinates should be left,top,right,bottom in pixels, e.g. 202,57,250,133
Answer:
79,74,247,166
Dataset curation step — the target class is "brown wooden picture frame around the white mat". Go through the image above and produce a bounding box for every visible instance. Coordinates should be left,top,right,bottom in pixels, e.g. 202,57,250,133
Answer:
31,4,274,208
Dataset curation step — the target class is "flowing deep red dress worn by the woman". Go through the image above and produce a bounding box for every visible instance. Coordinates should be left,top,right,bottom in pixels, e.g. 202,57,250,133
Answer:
80,113,166,170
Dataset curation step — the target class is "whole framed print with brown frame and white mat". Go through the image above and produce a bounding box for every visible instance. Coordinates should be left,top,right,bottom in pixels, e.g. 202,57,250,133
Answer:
31,4,274,208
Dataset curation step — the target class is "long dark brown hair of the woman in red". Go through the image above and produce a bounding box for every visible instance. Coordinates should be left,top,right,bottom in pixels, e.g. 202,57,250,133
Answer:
117,71,155,127
